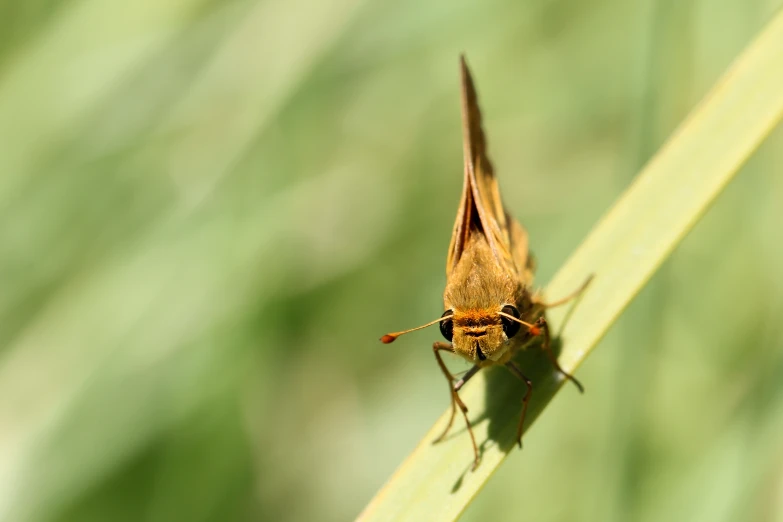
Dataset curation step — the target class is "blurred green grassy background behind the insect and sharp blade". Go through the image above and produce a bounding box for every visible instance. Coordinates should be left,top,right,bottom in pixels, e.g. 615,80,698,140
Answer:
0,0,783,522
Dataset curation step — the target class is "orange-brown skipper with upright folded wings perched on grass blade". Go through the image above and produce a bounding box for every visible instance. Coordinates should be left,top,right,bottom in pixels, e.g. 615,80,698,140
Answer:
381,56,586,468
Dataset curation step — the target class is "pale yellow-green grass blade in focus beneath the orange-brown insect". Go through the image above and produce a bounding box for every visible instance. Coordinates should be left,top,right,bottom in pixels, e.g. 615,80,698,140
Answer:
360,9,783,521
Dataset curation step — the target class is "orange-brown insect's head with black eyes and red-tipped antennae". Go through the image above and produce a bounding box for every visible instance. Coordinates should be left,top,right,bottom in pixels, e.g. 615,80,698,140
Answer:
381,305,536,366
